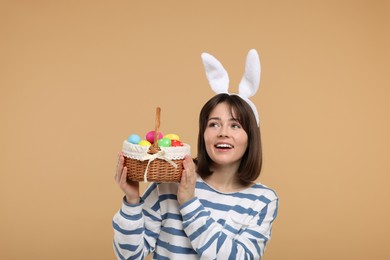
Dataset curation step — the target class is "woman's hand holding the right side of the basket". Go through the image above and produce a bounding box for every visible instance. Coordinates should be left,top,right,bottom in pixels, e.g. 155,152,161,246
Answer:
177,155,196,205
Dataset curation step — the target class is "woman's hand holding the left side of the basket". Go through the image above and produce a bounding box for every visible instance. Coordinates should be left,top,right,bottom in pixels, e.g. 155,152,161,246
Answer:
114,153,139,204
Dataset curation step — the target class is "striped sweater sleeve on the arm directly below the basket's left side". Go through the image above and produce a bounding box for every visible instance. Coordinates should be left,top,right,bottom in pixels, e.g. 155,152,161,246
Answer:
112,184,161,259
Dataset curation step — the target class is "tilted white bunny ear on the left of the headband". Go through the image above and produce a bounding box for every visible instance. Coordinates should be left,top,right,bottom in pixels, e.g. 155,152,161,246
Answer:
202,53,229,94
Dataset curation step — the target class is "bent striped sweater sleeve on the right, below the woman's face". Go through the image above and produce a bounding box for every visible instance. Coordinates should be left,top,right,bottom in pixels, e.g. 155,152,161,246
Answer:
180,196,278,259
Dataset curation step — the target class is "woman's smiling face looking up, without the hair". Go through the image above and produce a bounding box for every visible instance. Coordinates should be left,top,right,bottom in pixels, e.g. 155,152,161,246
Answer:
204,103,248,168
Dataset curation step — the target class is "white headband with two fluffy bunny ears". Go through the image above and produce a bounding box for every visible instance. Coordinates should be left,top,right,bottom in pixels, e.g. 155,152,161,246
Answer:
202,49,261,125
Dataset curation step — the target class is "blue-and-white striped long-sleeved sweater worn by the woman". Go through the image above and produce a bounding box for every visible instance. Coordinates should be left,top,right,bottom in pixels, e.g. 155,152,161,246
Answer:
112,177,278,260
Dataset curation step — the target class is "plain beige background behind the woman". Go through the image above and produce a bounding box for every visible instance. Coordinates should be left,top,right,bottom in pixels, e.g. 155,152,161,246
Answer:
0,0,390,260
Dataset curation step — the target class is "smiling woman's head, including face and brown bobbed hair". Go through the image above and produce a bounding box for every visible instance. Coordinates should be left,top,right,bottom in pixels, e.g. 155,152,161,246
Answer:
198,94,262,189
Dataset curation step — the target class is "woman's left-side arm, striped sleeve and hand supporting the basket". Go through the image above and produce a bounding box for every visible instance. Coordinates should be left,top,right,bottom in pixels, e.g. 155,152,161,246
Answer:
112,154,161,259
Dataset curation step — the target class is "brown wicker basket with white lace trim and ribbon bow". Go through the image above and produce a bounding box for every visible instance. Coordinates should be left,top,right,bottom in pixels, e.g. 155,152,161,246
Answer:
122,108,191,182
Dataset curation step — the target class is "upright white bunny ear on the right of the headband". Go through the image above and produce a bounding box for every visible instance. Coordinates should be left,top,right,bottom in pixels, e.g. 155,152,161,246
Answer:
238,49,261,98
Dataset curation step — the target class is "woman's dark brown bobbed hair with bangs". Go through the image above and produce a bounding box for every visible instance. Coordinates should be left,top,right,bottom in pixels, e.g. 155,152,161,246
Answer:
196,93,262,185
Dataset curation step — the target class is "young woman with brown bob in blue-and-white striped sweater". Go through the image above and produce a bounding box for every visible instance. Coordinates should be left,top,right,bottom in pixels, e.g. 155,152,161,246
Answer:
113,49,278,260
